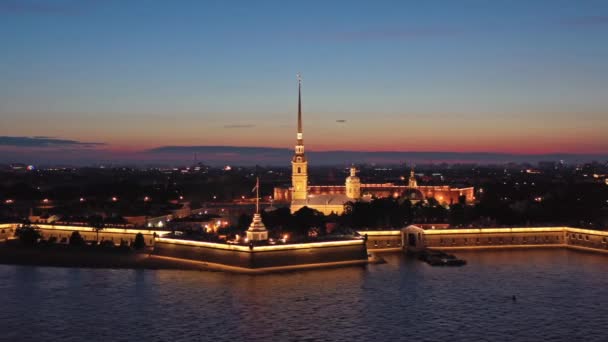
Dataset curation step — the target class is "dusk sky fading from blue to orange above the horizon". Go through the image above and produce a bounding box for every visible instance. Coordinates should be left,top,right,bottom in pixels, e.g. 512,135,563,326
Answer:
0,0,608,164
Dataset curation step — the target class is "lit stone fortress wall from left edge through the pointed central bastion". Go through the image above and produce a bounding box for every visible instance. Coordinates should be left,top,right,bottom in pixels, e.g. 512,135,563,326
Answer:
0,224,368,273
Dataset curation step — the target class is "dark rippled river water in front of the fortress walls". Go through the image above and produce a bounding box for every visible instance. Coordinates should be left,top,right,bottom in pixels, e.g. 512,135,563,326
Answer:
0,250,608,341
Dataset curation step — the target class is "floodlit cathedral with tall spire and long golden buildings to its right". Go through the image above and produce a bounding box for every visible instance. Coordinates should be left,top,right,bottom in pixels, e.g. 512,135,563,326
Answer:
274,77,475,215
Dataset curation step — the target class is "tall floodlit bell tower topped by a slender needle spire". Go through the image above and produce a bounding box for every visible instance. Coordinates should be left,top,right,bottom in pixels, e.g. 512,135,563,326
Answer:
291,74,308,200
